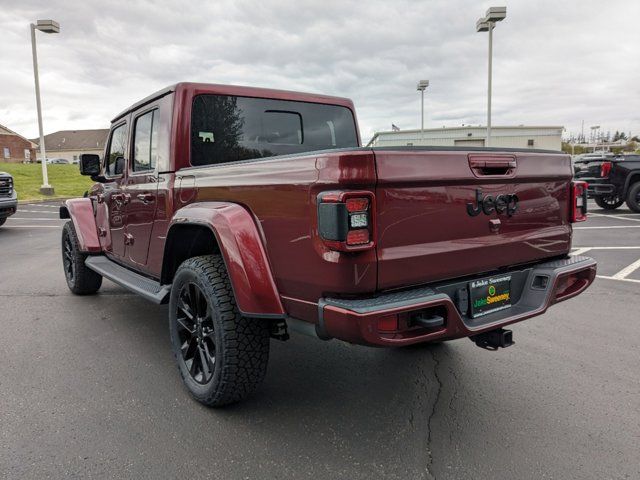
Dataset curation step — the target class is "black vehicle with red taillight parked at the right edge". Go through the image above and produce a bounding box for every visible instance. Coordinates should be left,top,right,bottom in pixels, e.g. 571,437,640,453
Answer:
574,153,640,213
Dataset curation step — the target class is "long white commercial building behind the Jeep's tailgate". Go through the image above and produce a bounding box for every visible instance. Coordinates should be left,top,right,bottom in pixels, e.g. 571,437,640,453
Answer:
368,126,563,150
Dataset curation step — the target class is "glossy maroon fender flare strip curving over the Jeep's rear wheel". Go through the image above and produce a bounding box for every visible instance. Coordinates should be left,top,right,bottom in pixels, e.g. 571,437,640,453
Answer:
167,202,285,318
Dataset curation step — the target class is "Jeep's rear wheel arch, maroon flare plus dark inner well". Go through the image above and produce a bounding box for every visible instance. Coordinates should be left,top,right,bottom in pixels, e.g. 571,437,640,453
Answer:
161,202,285,318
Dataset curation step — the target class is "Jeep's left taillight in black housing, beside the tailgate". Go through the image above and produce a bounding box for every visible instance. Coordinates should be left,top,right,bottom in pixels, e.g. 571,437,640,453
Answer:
318,191,375,252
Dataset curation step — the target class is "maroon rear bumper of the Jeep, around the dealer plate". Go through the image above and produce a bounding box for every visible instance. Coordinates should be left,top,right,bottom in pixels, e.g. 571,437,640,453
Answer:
316,257,596,346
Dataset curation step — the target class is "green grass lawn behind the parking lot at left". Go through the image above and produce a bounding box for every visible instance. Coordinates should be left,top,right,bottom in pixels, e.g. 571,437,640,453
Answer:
0,163,94,200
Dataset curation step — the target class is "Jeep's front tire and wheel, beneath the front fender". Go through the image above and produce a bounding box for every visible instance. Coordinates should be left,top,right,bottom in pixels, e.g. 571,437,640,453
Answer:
62,221,102,295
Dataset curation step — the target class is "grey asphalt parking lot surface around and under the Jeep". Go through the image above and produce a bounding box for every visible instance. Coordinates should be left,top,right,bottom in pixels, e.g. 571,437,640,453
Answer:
0,204,640,479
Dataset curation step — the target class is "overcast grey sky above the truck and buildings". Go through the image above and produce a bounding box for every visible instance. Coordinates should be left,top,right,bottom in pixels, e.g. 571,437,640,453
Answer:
0,0,640,142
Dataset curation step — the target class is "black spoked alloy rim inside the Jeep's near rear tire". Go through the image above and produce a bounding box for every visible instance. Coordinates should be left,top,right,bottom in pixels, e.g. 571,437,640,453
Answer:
175,282,216,385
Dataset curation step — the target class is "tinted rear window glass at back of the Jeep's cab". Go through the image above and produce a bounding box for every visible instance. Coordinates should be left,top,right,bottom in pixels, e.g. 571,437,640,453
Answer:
191,95,358,165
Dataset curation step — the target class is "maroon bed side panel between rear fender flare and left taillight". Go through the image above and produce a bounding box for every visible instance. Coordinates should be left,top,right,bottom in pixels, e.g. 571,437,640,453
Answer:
176,150,376,308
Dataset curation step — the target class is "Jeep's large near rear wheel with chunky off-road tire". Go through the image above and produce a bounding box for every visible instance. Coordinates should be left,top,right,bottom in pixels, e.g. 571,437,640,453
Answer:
169,255,269,407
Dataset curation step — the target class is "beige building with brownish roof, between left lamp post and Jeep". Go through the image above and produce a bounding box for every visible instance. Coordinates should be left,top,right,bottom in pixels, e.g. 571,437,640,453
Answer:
32,128,109,163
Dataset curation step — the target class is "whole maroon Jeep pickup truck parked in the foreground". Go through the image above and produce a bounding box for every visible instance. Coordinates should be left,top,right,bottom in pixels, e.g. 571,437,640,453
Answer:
60,83,596,406
